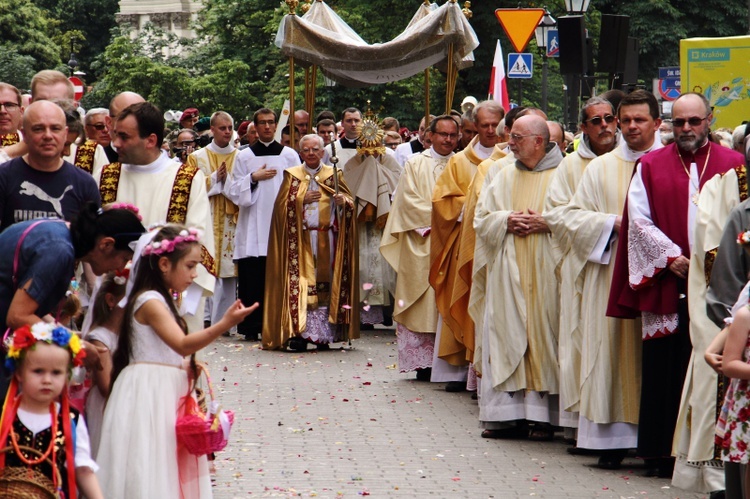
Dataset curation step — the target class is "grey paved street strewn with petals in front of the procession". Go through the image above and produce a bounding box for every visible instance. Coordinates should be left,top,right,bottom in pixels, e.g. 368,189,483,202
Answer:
204,329,706,499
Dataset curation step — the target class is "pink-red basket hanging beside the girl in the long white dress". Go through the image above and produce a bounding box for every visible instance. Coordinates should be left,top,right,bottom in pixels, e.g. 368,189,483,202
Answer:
175,367,234,456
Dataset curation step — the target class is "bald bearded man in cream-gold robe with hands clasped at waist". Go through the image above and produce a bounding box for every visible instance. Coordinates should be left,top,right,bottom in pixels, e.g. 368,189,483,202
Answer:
469,115,562,440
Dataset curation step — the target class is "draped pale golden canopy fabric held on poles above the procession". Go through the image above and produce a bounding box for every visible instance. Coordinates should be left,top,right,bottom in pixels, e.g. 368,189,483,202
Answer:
276,2,479,87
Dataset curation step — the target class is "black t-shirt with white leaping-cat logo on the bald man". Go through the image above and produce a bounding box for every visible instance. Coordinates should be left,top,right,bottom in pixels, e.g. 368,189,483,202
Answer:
0,158,101,231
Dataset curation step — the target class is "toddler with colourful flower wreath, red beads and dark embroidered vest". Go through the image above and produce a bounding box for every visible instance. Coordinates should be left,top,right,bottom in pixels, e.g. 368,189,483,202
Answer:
0,322,103,499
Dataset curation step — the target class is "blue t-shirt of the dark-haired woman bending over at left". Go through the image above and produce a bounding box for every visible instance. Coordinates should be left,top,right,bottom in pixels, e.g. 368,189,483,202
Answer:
0,220,75,335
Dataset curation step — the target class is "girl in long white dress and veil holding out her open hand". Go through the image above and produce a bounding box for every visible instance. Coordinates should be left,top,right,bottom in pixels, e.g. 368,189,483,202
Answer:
97,225,258,499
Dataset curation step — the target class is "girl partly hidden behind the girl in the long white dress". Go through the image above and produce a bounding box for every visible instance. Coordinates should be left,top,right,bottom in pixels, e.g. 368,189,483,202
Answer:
84,269,129,459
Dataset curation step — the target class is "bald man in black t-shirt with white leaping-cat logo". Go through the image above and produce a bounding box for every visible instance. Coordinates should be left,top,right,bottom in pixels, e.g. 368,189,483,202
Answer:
0,101,99,230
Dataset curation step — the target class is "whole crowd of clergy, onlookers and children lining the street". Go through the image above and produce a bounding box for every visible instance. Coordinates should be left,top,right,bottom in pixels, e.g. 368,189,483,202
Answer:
0,67,750,499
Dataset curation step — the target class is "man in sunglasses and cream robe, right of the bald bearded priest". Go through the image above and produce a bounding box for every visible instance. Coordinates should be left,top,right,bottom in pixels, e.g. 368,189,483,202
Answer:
544,97,621,446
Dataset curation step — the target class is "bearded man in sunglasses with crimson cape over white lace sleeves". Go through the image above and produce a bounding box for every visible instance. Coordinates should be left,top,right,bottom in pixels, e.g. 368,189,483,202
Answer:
607,92,741,477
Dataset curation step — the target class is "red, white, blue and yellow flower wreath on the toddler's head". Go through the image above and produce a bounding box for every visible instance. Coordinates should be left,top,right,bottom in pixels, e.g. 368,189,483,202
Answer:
5,322,86,373
